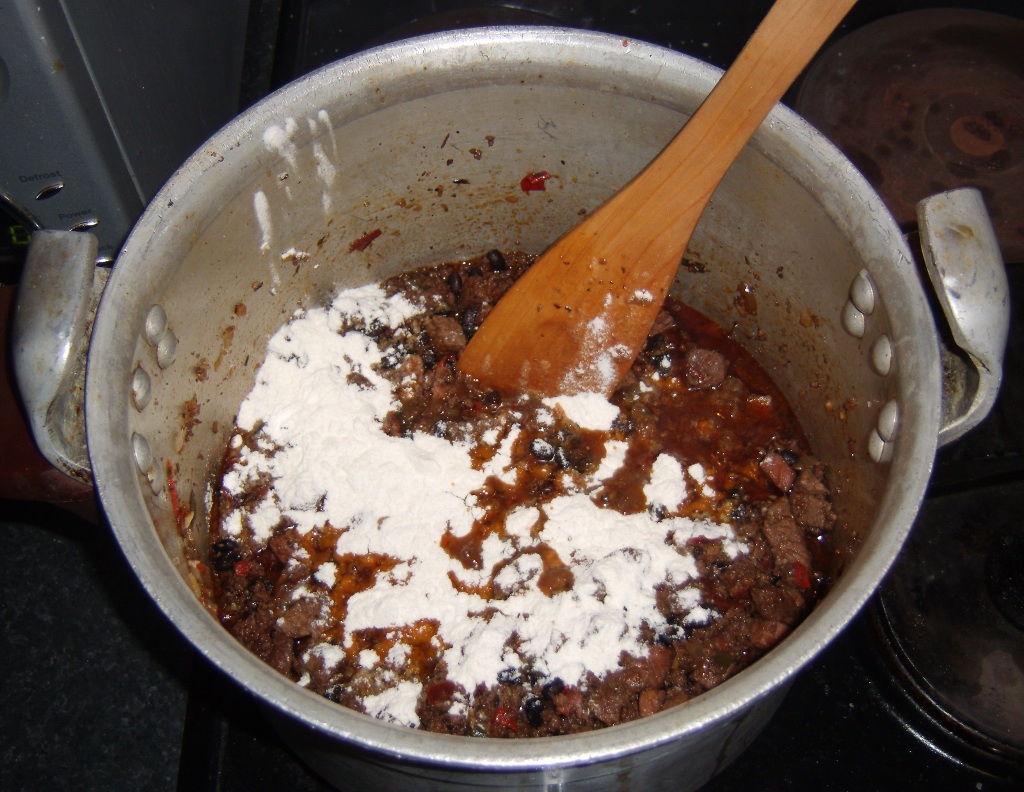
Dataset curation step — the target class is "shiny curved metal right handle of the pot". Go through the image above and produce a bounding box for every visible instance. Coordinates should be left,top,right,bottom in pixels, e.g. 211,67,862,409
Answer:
918,187,1010,446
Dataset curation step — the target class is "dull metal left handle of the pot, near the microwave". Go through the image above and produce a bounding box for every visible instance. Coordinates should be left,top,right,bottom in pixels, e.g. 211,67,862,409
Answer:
11,231,108,486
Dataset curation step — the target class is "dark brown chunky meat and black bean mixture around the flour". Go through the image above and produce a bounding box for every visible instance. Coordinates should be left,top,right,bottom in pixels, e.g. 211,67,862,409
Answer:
203,246,836,737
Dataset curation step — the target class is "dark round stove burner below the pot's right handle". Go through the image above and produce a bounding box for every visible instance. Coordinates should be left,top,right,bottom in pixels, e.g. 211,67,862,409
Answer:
879,476,1024,762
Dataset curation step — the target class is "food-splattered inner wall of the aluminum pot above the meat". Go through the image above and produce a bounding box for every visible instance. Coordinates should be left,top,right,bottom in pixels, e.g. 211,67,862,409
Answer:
119,26,900,692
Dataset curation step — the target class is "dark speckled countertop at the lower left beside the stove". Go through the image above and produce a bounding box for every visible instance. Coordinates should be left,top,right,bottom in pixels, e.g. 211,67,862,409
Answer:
0,503,194,792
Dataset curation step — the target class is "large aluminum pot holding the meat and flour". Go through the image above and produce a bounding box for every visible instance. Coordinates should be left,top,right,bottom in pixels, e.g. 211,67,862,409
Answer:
22,28,1007,792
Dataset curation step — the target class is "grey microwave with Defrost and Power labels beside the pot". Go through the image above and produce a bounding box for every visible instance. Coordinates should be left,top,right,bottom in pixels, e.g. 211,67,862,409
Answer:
0,0,249,285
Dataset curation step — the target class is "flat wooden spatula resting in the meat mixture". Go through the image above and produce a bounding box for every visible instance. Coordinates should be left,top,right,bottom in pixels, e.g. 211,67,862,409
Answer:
459,0,856,395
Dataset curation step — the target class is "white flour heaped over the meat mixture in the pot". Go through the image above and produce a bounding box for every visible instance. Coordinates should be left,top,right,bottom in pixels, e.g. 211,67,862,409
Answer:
223,287,746,725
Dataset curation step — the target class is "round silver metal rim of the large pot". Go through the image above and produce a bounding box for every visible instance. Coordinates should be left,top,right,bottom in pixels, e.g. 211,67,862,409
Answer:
86,27,940,770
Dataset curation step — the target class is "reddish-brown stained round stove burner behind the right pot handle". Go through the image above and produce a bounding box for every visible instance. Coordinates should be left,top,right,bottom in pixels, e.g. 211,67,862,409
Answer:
796,9,1024,261
